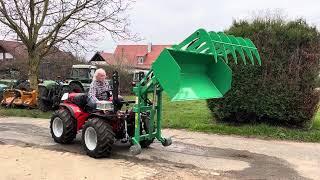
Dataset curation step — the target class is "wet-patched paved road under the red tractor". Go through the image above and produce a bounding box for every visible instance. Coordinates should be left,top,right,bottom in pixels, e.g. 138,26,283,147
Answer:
0,117,320,179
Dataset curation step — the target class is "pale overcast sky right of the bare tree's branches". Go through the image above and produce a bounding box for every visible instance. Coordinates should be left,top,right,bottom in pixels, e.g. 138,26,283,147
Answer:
86,0,320,57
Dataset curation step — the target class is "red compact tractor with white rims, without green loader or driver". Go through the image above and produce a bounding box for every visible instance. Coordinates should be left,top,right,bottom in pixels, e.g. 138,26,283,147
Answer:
50,72,153,158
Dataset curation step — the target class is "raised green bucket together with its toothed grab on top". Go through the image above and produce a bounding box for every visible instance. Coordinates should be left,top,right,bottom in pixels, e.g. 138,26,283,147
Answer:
152,29,261,101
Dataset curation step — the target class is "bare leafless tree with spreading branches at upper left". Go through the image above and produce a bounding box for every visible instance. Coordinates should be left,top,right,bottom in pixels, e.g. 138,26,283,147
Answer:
0,0,132,89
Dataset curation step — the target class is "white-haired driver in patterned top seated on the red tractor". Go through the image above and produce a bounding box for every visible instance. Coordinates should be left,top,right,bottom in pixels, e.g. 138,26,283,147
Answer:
88,68,110,109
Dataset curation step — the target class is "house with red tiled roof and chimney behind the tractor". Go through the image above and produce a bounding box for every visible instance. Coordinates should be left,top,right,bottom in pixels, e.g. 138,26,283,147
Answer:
90,43,171,73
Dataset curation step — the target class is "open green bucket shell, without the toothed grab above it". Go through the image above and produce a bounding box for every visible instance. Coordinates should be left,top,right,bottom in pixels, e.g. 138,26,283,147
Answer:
152,49,231,101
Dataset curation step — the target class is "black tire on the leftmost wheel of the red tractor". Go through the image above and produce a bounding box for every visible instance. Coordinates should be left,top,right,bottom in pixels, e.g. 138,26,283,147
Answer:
50,108,77,144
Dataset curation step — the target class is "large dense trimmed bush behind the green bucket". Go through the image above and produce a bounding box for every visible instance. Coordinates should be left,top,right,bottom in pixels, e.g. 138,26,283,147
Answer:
207,18,320,126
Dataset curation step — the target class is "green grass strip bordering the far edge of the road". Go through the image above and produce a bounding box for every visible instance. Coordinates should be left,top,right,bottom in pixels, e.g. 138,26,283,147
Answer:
0,96,320,142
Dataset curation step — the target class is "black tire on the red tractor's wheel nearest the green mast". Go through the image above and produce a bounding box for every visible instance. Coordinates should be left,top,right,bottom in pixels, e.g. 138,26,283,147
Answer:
82,118,115,158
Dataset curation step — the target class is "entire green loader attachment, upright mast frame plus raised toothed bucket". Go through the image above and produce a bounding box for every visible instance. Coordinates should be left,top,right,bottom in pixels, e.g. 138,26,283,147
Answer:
130,29,261,154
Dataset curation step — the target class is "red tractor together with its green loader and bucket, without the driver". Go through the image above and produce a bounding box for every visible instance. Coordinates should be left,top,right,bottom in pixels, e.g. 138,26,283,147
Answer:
50,29,261,158
